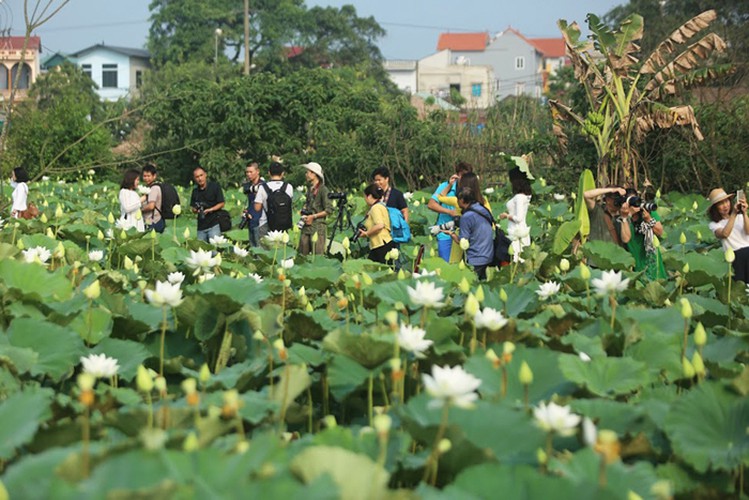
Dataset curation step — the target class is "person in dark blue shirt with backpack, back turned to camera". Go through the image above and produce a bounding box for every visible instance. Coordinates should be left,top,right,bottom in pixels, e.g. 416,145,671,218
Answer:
446,189,494,281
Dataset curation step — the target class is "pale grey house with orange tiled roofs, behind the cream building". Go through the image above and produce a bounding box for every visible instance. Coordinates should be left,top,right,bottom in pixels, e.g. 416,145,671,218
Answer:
437,27,565,100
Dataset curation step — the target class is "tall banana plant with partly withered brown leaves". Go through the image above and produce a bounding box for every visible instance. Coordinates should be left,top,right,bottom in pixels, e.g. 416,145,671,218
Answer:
549,10,731,186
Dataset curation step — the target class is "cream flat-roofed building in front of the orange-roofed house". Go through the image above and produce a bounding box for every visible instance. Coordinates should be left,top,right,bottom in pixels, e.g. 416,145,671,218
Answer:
417,49,494,109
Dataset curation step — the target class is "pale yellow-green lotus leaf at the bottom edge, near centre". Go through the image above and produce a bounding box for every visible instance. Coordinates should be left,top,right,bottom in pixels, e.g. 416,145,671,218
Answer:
289,446,390,499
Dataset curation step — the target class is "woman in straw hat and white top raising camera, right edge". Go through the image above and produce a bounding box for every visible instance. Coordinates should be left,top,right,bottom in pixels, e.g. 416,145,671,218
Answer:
707,188,749,283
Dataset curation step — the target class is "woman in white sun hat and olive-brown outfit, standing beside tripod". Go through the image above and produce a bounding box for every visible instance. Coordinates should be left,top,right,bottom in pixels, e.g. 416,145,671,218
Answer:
297,162,333,255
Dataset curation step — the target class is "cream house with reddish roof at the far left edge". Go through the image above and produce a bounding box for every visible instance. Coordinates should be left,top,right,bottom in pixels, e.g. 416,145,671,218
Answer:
0,36,42,100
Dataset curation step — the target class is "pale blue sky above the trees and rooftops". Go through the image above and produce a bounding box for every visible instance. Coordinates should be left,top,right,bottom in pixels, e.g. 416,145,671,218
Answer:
0,0,625,59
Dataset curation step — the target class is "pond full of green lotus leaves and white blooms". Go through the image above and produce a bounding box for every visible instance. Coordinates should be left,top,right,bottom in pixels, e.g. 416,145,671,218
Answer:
0,177,749,500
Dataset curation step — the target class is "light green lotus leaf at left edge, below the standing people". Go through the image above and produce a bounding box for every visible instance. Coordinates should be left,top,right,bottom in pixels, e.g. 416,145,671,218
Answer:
0,259,73,302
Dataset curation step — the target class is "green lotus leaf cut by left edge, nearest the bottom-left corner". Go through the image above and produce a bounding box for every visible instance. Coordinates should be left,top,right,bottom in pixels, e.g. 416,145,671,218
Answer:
0,389,54,460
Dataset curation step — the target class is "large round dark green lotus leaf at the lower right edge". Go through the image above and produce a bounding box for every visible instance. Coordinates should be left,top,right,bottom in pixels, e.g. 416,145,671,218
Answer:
665,382,749,473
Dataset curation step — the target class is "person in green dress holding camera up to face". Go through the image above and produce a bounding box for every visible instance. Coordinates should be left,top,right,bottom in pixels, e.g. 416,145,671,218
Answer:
619,189,668,280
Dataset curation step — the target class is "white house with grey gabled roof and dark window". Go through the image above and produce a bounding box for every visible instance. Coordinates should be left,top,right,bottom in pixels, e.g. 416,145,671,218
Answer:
70,43,151,101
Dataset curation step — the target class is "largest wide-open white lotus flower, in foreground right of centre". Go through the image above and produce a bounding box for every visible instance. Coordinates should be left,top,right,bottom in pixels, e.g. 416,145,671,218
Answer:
422,365,481,409
